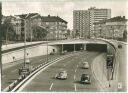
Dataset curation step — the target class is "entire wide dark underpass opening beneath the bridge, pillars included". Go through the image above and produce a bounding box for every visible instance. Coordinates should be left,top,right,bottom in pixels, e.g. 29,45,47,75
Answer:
57,43,107,52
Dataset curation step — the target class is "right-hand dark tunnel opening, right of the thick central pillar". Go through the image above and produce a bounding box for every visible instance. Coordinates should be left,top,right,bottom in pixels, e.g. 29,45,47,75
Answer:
86,43,107,52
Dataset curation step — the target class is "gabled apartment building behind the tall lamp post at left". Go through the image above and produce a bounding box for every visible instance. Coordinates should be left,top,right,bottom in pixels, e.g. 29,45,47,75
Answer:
17,13,41,41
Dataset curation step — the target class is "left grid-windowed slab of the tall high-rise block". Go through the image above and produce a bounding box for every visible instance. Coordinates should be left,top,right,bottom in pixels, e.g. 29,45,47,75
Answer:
73,10,90,37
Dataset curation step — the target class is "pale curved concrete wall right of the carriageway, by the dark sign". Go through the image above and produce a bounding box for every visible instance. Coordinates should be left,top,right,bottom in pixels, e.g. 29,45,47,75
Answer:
92,54,117,92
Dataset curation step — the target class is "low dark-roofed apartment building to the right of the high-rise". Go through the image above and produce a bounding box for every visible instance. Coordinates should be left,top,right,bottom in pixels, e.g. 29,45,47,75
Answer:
94,16,127,40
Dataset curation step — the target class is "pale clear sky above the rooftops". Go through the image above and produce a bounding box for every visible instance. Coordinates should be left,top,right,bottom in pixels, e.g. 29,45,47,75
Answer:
0,0,128,29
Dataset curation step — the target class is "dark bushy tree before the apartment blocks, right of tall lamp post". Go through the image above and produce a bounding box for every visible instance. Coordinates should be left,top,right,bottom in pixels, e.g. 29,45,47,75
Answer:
33,26,48,40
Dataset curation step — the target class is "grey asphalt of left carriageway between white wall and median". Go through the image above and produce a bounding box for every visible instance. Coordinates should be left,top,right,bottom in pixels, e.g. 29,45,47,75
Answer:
1,55,60,90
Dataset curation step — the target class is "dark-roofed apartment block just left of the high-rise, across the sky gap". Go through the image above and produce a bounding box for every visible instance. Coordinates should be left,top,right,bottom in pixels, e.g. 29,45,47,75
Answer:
41,15,67,40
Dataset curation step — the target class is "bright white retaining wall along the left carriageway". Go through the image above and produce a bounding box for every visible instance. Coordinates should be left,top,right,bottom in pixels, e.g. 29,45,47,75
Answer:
2,44,58,64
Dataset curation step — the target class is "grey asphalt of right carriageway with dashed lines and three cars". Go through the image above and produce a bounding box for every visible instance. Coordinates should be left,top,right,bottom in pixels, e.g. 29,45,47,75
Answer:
19,51,101,92
